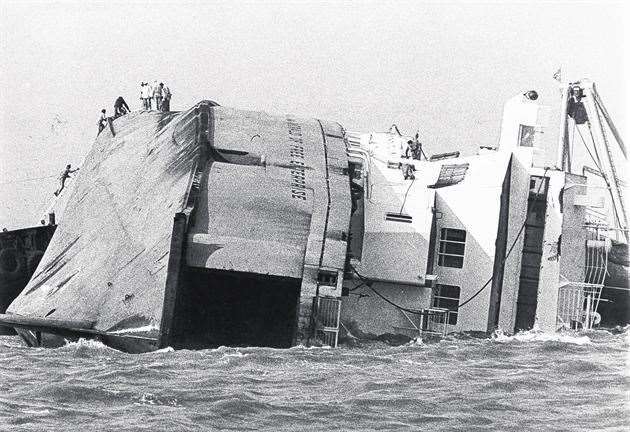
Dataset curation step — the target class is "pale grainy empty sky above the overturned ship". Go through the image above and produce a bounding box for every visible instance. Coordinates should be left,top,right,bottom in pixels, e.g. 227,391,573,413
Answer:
0,0,630,229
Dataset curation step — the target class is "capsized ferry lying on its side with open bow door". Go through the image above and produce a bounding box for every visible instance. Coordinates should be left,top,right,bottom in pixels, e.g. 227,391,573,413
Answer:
0,81,628,352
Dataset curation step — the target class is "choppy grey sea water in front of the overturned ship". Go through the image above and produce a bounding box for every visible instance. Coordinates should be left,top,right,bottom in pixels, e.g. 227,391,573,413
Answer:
0,328,630,431
